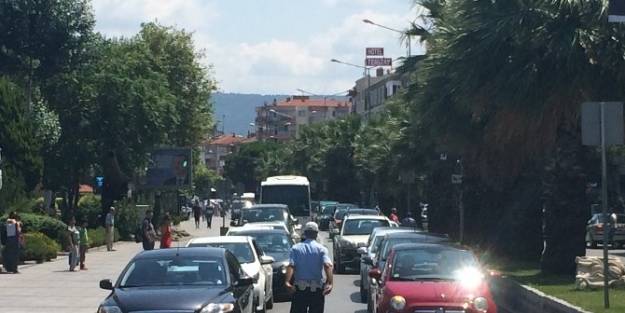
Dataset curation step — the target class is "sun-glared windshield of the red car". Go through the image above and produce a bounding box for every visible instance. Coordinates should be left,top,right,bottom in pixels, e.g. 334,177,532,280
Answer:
390,247,479,280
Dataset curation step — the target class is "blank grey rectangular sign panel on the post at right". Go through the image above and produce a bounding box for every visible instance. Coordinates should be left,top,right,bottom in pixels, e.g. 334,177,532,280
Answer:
582,102,625,146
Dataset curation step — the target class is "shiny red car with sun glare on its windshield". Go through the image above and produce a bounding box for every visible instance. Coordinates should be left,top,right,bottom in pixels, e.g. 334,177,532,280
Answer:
369,243,497,313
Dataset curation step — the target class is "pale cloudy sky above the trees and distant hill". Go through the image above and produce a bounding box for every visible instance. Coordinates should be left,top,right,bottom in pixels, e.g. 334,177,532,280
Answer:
92,0,424,95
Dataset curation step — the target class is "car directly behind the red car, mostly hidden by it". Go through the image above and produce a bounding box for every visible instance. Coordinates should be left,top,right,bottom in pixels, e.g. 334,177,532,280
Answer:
363,231,449,312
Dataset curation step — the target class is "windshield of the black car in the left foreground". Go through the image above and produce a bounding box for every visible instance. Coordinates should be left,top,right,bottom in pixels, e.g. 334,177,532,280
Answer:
120,257,226,288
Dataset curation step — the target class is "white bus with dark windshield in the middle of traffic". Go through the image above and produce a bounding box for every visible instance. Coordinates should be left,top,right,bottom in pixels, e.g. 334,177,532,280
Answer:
260,176,311,224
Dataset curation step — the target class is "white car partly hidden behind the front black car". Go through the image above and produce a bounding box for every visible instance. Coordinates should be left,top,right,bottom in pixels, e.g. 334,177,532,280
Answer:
187,236,274,313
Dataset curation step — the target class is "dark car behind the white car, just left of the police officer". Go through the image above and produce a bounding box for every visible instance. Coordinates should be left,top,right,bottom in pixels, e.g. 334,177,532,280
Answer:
230,229,294,299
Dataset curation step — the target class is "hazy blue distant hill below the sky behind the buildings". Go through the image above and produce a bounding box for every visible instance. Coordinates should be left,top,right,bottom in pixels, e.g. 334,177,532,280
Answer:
212,92,288,135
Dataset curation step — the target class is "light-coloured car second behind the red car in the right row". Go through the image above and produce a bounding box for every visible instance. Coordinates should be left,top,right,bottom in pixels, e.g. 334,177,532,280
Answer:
357,227,415,303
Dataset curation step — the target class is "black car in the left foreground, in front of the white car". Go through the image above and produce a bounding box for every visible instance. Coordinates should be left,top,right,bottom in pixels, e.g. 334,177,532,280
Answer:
98,248,254,313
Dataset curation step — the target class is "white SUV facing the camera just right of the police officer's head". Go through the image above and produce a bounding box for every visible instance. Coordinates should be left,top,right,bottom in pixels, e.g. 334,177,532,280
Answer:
334,215,390,274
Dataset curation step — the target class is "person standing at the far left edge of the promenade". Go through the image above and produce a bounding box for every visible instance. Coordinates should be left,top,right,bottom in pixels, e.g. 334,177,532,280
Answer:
0,212,22,274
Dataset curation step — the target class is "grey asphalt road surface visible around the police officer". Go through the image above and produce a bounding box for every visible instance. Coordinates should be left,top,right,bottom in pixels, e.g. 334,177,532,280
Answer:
269,232,367,313
